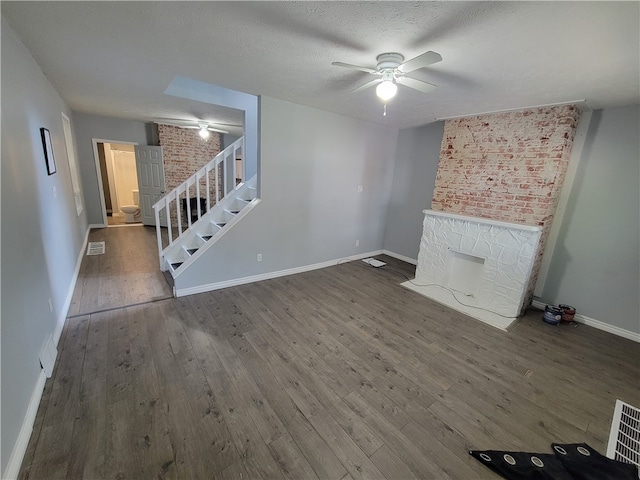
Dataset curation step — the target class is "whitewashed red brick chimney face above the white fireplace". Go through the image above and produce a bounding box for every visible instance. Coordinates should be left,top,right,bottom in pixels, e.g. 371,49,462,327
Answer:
431,105,580,304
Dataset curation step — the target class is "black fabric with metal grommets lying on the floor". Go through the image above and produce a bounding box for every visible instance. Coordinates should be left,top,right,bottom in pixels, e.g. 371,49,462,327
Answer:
469,443,638,480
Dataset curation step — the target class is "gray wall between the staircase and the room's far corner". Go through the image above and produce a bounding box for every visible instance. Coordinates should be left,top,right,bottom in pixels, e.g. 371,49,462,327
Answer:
176,97,397,289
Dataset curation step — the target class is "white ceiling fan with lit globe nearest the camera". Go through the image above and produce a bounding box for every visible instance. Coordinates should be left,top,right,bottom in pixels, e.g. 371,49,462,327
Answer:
331,51,442,103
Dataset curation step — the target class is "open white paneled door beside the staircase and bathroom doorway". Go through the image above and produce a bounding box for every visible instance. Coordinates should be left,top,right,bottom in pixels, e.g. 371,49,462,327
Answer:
135,145,165,225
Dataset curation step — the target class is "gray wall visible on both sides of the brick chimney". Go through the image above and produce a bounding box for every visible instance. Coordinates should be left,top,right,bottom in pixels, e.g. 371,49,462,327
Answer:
384,106,640,333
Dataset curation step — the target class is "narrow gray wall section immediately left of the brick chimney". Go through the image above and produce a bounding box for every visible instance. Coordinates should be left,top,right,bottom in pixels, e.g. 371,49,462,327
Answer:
384,122,444,260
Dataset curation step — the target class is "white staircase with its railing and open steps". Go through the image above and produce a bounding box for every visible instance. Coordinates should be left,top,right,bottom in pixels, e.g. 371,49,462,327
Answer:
153,137,259,279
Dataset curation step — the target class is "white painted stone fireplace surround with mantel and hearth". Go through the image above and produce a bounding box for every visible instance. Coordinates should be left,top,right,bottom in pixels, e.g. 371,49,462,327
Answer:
402,210,542,330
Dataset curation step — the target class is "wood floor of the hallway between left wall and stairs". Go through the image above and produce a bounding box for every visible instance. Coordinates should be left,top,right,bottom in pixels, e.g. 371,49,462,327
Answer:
69,226,172,317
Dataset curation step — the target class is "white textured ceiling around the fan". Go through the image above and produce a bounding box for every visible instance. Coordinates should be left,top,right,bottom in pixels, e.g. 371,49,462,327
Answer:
2,1,640,128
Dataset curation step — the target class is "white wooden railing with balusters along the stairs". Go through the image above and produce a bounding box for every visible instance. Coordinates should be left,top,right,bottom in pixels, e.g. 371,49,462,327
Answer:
153,137,246,265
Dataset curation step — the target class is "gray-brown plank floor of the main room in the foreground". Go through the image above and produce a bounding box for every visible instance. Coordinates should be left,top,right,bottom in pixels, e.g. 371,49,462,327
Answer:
20,256,640,479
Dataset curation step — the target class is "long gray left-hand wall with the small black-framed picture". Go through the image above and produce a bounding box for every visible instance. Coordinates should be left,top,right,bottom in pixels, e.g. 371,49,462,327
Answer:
1,18,87,478
